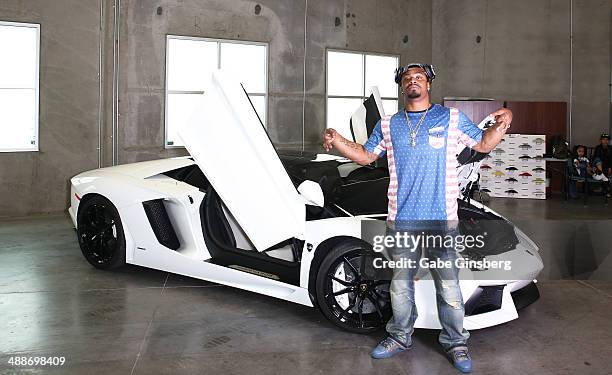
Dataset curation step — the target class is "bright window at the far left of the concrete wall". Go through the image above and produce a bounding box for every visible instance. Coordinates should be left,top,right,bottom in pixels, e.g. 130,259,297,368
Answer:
0,22,40,152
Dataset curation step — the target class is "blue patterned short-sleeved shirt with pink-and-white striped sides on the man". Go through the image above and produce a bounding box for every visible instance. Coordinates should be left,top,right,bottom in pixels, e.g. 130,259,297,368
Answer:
364,104,482,221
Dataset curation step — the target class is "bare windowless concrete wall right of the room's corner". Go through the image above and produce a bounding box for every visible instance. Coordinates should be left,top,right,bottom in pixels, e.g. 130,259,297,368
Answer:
432,0,612,144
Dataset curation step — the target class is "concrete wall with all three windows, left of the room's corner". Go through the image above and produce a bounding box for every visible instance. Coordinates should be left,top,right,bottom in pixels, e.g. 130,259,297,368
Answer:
0,0,431,216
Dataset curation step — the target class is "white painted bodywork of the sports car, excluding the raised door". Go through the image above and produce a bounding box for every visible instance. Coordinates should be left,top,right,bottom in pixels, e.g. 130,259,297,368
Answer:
70,160,543,330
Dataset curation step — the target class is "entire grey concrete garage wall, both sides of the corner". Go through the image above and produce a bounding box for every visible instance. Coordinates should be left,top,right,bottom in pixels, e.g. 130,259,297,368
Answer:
0,0,612,216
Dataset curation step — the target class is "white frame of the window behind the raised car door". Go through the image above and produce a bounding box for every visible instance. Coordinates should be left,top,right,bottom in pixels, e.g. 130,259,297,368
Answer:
164,34,270,149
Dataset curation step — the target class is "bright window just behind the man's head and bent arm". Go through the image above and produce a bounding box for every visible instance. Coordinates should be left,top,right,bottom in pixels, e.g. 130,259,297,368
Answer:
327,50,399,139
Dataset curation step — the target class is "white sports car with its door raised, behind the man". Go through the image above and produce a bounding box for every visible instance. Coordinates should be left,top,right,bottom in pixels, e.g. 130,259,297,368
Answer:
69,72,542,332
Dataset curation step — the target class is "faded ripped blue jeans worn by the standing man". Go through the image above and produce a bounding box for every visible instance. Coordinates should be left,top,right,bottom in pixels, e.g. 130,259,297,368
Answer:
385,223,470,350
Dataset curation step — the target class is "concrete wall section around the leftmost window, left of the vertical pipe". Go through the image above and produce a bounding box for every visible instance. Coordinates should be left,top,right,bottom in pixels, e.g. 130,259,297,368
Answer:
0,0,100,216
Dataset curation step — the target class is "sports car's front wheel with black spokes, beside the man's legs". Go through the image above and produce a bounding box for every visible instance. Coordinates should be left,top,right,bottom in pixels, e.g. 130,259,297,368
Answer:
316,240,391,333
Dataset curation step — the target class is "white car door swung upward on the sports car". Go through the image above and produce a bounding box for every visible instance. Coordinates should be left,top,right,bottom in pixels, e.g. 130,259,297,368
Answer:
178,71,306,251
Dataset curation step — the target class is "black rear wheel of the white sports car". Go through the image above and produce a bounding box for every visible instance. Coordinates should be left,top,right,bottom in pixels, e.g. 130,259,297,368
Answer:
77,195,125,270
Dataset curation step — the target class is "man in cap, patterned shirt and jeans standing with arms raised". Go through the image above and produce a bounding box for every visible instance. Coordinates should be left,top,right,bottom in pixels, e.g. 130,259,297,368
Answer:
323,64,512,372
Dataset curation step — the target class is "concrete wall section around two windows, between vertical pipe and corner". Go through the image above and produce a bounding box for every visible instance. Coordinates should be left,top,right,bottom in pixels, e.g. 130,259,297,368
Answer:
119,0,431,163
